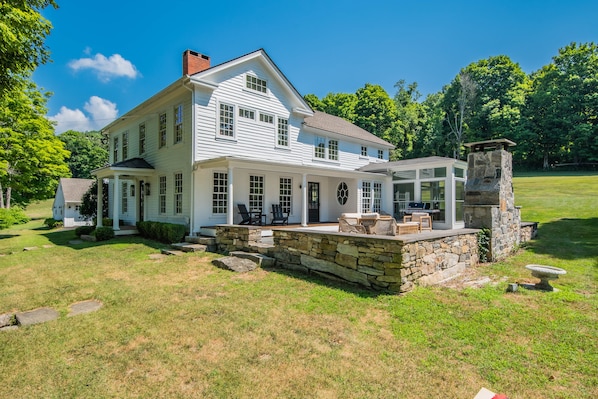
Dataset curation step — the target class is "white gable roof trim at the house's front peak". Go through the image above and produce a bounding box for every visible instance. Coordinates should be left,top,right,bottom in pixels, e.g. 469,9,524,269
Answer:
190,48,313,116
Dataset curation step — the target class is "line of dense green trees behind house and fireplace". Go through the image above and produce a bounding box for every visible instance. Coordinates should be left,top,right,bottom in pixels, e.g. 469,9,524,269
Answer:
304,43,598,169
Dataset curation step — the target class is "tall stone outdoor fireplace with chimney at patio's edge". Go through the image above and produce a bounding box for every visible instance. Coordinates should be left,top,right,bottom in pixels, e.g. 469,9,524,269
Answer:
464,139,521,261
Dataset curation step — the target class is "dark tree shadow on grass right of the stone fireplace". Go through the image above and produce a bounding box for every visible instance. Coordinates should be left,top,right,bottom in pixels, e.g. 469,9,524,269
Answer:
528,218,598,260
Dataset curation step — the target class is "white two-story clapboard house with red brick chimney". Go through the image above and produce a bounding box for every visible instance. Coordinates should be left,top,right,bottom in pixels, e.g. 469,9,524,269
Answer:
94,49,393,233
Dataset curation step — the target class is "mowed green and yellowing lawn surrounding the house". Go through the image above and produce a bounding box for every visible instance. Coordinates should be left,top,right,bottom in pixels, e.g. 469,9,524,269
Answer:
0,175,598,399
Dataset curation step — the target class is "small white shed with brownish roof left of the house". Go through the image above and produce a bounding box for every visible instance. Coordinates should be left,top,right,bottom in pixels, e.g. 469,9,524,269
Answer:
52,178,94,227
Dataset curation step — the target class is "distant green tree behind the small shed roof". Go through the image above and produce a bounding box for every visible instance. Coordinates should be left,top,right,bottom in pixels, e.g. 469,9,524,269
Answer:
58,130,108,179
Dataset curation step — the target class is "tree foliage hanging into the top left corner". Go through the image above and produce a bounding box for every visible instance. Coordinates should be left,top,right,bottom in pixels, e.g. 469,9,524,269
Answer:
0,0,58,97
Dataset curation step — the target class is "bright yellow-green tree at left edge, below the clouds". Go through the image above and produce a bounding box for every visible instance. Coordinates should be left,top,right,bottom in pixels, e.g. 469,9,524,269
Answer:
0,80,70,208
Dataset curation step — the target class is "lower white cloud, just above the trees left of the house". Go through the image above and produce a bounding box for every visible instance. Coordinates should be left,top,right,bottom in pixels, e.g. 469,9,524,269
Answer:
48,96,118,134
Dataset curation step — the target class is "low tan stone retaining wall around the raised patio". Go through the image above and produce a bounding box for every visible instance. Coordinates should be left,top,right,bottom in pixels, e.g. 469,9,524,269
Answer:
216,225,478,293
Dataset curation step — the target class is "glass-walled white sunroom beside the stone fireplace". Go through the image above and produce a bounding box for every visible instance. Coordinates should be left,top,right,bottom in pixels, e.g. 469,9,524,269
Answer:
360,157,467,230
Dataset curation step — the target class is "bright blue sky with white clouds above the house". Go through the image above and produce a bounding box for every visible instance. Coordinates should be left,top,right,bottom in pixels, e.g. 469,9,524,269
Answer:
34,0,598,133
